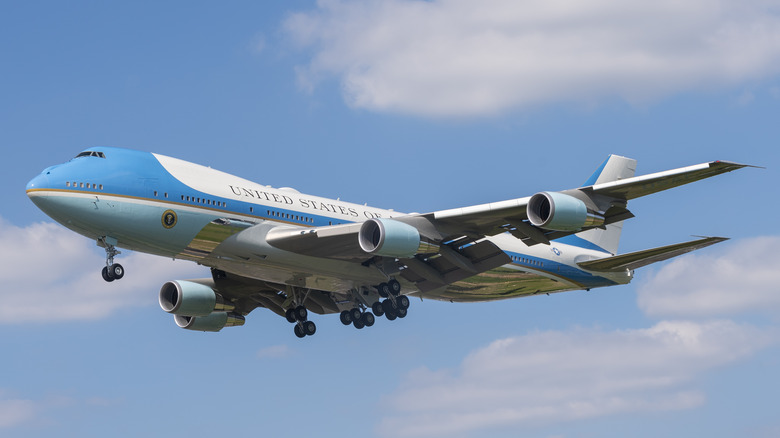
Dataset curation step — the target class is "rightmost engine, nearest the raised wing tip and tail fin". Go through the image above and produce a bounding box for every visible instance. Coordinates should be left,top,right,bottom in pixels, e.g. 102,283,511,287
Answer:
527,192,604,231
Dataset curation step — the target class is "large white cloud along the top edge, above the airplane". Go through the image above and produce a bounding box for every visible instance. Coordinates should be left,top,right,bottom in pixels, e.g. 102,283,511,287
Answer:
284,0,780,116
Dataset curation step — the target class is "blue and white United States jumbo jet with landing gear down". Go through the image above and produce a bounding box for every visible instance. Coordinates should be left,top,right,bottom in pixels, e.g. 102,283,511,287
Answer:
26,147,753,338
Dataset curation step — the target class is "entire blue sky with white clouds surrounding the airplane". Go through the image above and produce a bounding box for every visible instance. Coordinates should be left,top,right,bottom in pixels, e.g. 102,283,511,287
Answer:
0,0,780,437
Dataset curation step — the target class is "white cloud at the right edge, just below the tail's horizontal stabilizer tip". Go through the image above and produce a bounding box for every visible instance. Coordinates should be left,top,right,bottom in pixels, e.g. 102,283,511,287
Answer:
638,236,780,317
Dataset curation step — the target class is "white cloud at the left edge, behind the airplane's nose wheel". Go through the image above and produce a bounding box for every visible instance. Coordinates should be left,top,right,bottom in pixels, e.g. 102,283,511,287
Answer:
0,218,204,324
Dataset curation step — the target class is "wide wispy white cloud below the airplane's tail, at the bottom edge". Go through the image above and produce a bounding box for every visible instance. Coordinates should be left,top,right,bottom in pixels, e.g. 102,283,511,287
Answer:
379,321,772,437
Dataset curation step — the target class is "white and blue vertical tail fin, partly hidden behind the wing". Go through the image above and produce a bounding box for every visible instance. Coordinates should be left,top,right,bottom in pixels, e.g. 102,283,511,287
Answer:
577,155,636,255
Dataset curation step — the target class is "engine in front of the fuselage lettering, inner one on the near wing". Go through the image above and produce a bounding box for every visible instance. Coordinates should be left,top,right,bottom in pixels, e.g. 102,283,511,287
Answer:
358,218,438,258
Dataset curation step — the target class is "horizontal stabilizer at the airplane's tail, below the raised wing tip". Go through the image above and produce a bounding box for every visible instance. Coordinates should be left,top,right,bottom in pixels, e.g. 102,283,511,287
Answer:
577,237,728,272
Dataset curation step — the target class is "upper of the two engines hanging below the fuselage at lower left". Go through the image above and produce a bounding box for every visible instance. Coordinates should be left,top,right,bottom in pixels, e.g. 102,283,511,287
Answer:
160,280,235,316
